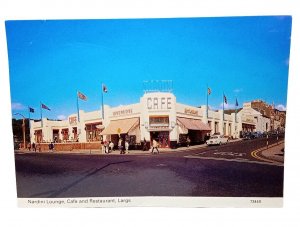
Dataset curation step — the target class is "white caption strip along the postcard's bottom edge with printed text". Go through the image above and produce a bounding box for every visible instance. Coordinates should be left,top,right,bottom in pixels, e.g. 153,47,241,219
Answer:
18,196,283,208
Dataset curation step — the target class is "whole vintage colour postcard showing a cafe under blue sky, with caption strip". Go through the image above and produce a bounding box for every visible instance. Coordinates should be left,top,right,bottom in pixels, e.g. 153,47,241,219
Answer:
6,16,292,207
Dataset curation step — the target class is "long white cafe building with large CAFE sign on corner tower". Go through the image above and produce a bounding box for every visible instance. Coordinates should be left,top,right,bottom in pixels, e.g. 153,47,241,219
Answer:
30,81,270,149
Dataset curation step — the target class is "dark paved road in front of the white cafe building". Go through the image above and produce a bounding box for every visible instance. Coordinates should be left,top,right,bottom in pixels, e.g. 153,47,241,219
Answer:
15,139,283,198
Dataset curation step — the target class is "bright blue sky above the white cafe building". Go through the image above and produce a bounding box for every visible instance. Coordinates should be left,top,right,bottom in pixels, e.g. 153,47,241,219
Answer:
6,16,291,119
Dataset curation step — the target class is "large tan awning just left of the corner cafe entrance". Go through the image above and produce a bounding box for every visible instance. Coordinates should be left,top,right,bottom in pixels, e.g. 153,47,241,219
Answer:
101,117,139,135
